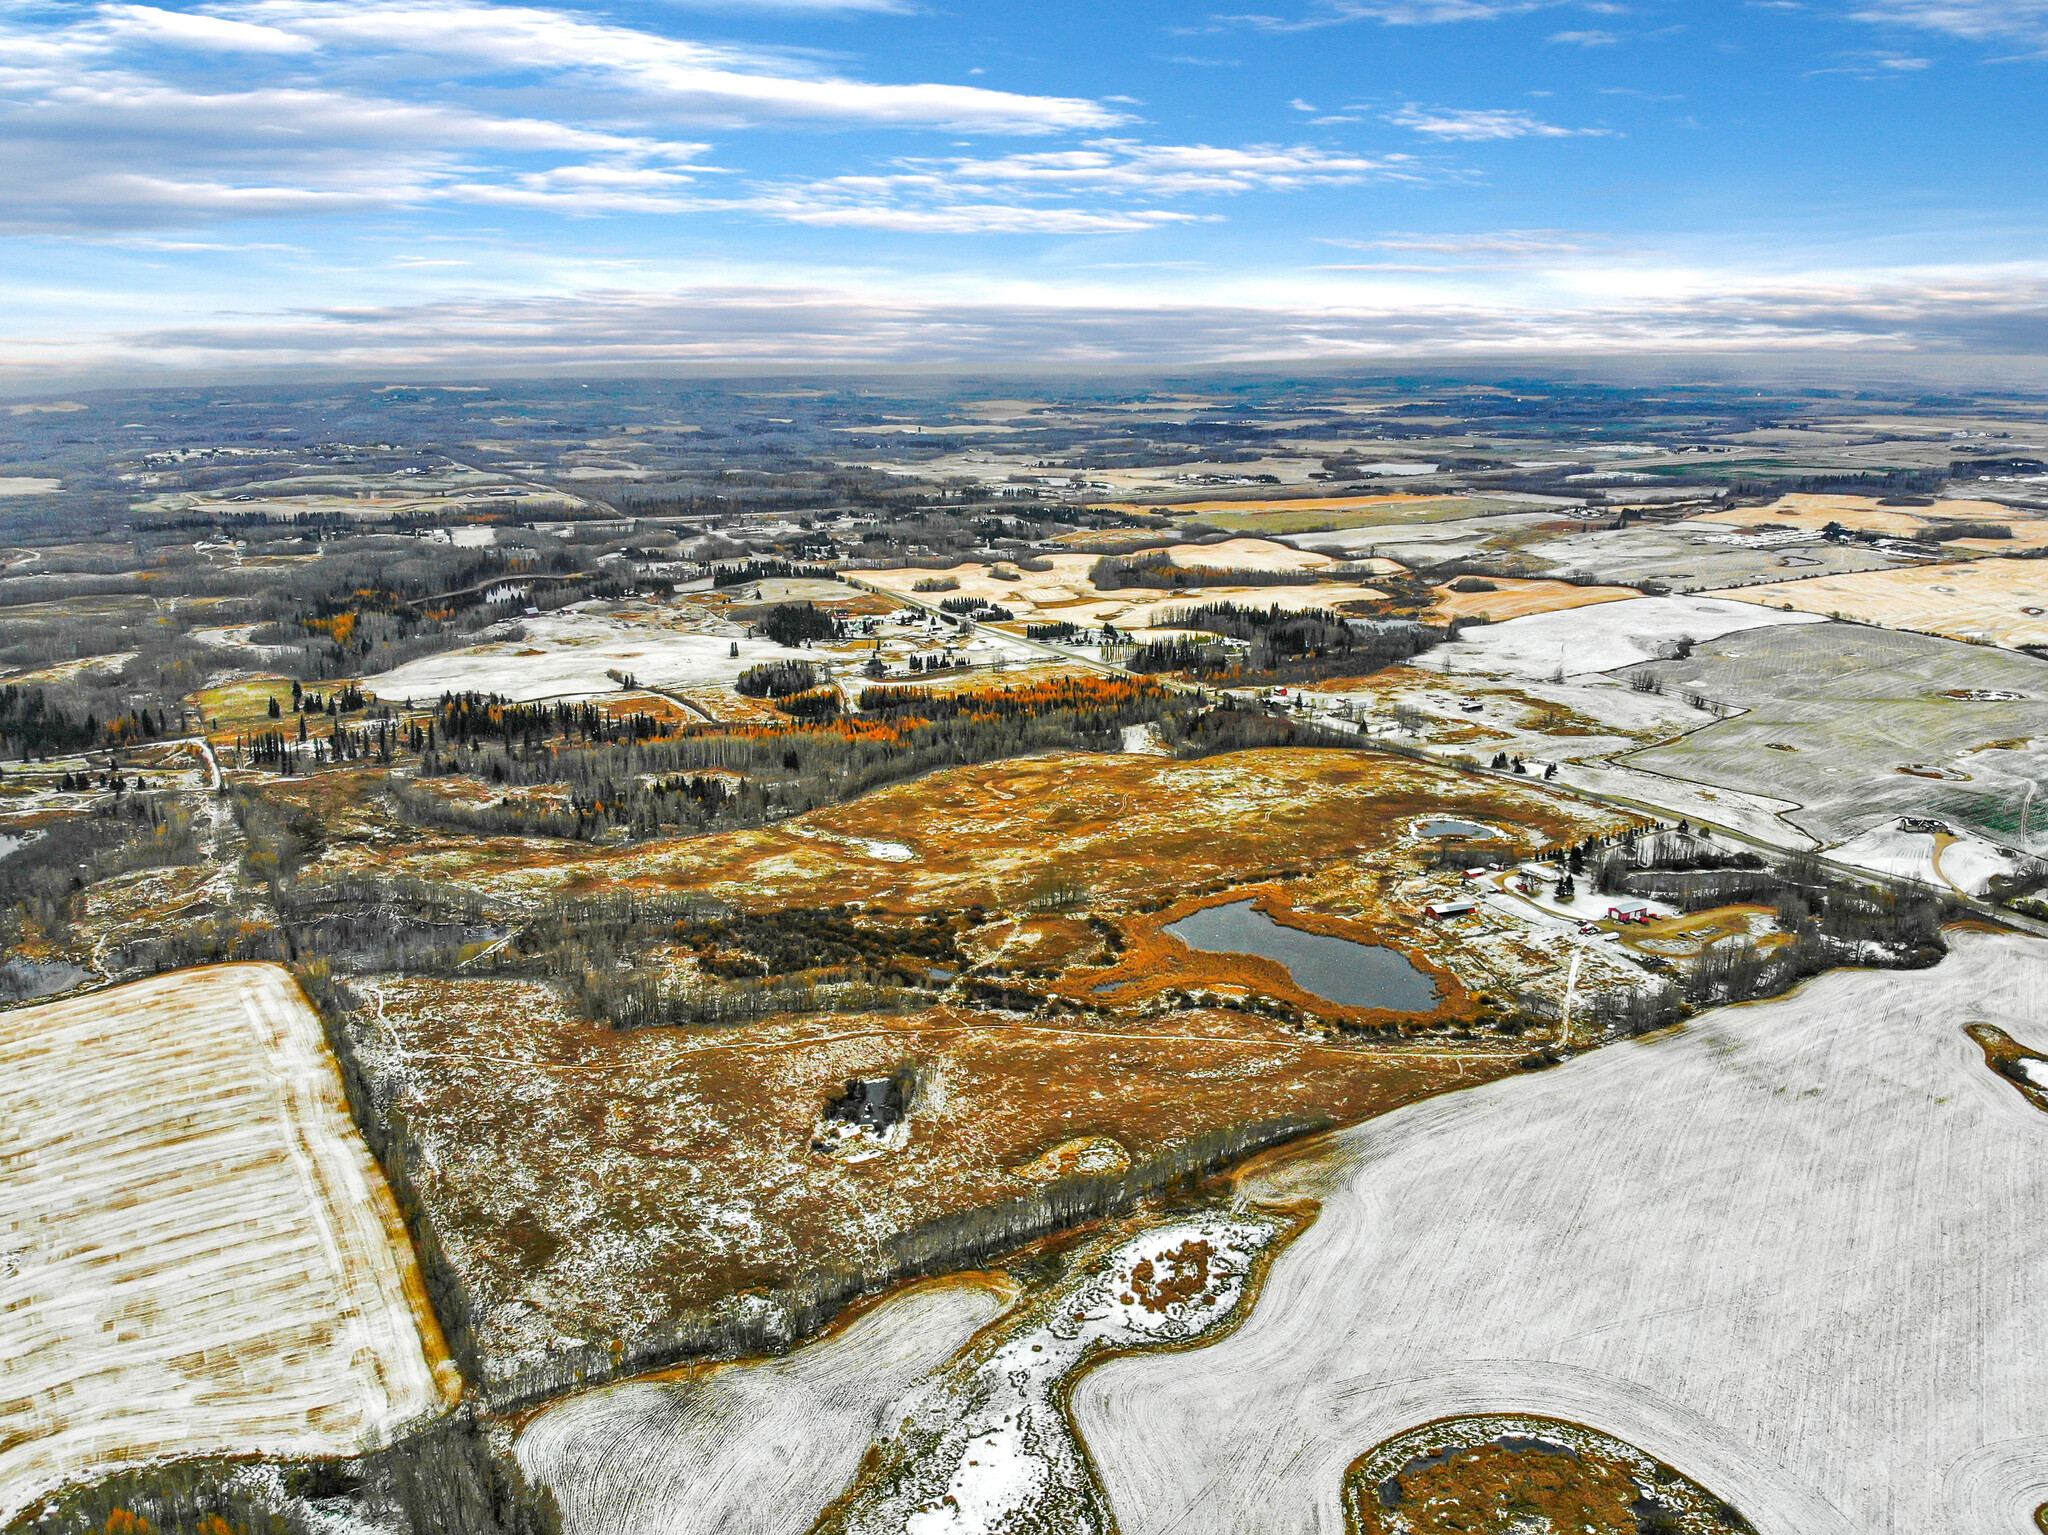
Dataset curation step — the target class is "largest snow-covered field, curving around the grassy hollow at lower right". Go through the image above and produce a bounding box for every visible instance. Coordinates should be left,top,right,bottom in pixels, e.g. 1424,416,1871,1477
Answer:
1073,931,2048,1535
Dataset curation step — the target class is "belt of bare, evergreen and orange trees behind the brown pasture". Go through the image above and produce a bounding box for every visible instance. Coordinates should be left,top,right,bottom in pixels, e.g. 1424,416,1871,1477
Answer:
391,675,1337,841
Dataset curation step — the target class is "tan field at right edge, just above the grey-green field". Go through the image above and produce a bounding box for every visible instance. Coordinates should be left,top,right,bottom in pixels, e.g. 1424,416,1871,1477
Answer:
1710,559,2048,649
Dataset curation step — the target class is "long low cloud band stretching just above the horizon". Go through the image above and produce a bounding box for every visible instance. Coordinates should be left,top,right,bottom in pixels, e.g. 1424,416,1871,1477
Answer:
32,270,2048,382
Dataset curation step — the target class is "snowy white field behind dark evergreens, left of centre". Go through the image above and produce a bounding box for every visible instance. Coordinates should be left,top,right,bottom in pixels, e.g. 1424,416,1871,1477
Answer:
365,612,825,702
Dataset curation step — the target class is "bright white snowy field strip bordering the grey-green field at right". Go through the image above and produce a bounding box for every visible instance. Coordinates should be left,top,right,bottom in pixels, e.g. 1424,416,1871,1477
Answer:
1430,598,1827,677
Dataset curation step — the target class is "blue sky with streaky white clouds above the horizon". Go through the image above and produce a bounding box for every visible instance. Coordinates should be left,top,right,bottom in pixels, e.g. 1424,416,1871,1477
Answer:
0,0,2048,389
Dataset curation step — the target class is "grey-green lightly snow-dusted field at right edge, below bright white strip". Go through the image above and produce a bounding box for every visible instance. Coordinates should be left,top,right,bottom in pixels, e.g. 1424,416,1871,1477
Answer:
1626,624,2048,851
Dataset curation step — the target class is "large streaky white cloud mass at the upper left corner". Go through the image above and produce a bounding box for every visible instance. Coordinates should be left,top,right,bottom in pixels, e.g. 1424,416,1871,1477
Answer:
0,0,1124,235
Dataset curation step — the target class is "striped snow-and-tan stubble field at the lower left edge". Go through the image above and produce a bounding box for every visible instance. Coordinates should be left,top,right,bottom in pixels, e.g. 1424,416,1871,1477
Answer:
0,964,457,1519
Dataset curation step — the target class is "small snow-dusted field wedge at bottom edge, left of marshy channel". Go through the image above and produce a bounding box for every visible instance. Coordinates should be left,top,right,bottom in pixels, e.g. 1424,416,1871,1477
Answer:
514,1277,1010,1535
